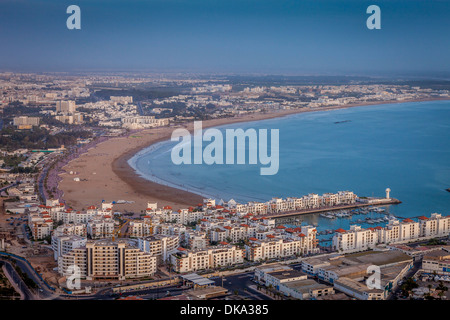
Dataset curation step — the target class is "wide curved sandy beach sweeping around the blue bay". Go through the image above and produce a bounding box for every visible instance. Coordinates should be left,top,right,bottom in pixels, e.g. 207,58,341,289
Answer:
59,99,448,212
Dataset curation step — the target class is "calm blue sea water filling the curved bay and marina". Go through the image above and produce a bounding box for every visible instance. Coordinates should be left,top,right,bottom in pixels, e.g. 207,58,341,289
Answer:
129,101,450,235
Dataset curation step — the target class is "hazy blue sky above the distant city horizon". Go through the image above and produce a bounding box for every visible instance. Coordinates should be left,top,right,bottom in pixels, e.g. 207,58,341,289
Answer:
0,0,450,74
